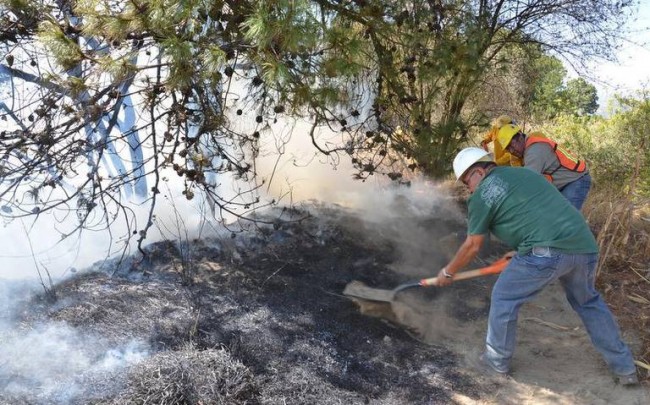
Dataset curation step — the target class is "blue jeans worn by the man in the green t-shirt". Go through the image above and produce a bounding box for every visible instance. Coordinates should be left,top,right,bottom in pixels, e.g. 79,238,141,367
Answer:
485,248,636,375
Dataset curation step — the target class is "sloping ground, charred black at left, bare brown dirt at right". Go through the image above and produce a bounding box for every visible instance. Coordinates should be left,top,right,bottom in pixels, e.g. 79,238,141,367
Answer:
0,200,650,404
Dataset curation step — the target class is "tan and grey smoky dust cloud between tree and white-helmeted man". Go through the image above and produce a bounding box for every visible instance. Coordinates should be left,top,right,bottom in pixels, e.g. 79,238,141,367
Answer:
258,117,465,277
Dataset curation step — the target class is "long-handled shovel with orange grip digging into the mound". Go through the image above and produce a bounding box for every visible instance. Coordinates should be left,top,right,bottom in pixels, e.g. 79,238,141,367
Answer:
343,256,511,302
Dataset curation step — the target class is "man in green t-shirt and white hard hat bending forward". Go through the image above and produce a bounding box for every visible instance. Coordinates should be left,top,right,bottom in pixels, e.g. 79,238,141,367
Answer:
438,148,638,385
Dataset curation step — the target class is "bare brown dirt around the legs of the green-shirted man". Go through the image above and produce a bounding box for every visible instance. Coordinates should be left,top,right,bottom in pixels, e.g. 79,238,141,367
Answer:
382,283,650,405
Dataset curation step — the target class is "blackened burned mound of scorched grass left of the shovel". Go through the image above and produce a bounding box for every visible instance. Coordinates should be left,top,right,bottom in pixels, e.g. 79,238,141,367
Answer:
0,207,498,404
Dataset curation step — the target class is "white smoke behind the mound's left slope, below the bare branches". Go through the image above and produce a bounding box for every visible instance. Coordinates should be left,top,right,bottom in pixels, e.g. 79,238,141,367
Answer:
0,187,215,283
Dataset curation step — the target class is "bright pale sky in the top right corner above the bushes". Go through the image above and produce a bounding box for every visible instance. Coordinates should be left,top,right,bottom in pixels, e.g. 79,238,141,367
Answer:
592,0,650,113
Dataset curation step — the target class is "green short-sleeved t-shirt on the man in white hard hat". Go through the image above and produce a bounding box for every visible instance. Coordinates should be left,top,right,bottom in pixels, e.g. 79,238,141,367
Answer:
468,167,598,254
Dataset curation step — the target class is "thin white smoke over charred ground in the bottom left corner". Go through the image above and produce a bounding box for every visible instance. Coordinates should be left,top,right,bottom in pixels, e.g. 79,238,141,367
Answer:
0,310,148,404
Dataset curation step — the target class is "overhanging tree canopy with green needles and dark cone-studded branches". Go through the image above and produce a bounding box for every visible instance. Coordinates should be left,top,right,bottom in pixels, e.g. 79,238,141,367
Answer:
0,0,633,246
